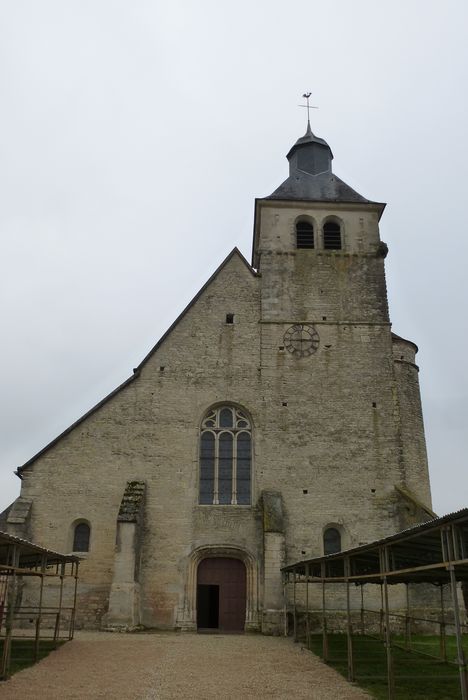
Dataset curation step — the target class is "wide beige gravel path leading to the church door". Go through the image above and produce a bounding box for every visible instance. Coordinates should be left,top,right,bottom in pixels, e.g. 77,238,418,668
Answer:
0,632,369,700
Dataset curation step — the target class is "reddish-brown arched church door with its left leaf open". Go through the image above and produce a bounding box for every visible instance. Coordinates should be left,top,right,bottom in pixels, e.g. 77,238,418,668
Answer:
197,557,247,632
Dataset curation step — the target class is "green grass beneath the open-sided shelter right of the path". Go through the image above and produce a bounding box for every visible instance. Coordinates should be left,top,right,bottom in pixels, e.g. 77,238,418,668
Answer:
310,634,468,700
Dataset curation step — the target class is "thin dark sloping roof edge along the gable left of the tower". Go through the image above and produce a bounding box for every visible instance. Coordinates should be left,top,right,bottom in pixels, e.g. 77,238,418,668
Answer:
14,246,259,479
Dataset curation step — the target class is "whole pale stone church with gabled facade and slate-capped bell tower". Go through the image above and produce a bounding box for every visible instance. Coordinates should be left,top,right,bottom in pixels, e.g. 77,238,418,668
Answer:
0,124,433,633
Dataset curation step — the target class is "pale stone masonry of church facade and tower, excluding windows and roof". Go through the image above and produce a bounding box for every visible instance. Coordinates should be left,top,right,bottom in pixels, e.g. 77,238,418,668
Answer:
11,194,436,628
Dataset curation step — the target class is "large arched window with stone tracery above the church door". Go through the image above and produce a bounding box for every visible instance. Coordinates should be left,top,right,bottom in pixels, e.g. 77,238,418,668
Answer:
199,406,252,506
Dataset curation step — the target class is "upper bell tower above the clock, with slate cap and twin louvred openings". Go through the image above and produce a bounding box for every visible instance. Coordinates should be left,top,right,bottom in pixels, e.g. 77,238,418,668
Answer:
252,124,389,323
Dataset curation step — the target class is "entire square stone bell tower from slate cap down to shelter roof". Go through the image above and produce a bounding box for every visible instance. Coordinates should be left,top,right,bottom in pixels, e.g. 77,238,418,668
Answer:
252,116,432,592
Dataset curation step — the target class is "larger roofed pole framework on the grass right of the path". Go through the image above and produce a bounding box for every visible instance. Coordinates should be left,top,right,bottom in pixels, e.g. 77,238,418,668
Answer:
282,508,468,700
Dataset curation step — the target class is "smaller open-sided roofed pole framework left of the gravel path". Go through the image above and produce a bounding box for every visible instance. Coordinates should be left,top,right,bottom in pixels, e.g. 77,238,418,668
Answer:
0,532,79,680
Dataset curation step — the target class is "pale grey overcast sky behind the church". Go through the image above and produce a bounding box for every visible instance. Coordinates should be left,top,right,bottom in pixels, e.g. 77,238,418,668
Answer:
0,0,468,513
